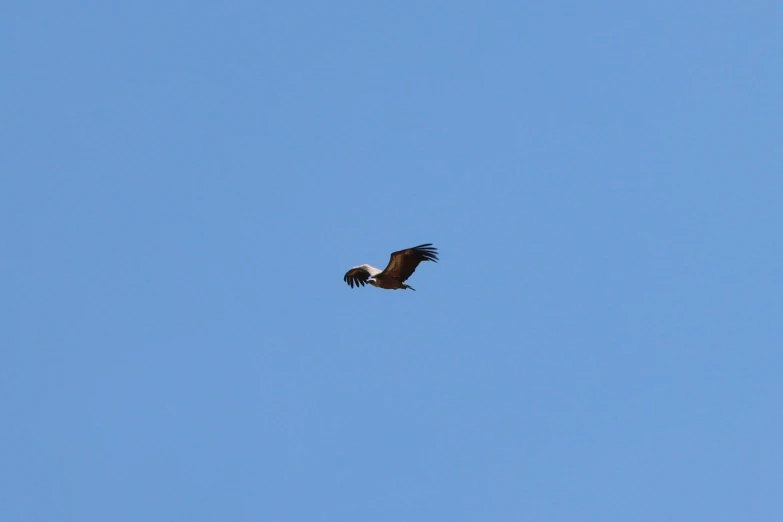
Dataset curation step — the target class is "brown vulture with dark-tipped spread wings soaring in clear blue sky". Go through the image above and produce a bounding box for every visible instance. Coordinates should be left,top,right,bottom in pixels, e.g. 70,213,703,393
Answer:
343,243,438,292
